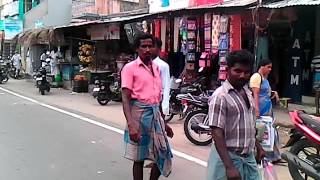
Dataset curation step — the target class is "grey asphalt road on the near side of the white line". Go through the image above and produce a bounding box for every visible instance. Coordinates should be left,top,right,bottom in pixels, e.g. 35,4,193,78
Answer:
0,90,206,180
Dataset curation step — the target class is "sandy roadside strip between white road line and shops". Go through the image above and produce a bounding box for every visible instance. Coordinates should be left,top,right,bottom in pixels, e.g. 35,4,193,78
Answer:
0,79,291,180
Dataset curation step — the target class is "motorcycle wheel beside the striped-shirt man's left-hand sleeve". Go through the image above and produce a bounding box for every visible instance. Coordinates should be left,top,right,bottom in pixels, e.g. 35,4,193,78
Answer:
183,110,212,146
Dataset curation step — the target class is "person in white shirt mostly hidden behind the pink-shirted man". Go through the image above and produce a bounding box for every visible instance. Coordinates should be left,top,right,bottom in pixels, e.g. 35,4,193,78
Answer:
152,38,170,115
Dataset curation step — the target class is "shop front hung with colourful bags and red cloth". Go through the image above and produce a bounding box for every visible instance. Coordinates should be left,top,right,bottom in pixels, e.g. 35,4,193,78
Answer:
144,0,253,88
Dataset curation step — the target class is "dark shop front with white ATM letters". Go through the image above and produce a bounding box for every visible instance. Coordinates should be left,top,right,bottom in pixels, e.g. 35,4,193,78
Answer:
250,2,319,102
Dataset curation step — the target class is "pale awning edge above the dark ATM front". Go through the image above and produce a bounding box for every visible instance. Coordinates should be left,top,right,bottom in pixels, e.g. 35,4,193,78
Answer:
262,0,320,9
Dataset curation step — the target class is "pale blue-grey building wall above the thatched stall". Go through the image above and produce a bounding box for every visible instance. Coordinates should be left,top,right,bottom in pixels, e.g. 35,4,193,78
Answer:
24,0,72,29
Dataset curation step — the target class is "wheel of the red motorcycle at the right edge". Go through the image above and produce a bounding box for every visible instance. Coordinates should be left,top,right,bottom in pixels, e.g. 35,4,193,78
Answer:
288,139,320,180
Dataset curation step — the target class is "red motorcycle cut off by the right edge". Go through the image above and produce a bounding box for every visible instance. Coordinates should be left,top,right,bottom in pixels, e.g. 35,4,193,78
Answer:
282,111,320,180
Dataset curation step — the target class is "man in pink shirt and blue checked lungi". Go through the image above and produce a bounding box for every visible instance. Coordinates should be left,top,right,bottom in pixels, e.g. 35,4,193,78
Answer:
121,34,173,180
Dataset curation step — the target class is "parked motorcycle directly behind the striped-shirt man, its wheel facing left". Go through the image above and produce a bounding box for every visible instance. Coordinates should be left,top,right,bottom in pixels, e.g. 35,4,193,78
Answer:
178,94,212,146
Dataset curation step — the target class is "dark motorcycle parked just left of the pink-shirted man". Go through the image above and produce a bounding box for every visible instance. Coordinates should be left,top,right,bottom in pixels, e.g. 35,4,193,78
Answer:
93,73,122,106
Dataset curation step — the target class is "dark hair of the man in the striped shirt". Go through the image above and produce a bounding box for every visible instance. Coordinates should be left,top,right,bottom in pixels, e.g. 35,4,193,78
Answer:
227,50,254,69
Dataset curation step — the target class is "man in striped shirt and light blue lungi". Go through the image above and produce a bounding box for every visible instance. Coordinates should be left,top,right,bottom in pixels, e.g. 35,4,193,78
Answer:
207,50,264,180
